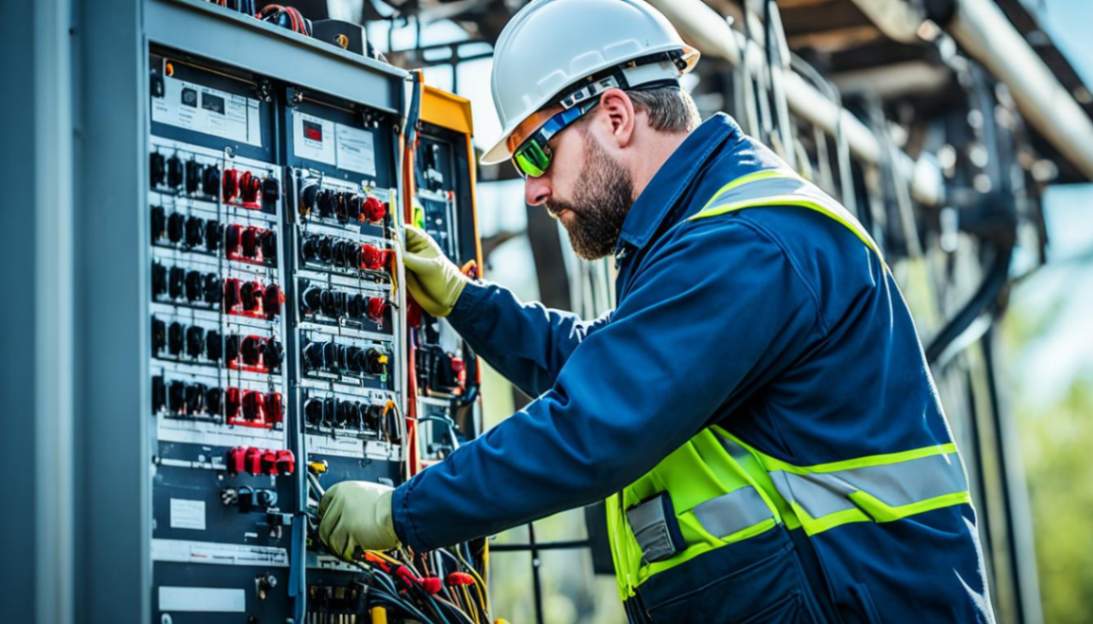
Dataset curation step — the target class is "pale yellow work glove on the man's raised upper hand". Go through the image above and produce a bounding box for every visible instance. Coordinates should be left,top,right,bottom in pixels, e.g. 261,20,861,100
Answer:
402,225,470,316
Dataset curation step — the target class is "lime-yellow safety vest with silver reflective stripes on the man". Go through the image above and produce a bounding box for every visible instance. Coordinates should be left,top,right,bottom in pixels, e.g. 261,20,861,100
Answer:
607,168,971,601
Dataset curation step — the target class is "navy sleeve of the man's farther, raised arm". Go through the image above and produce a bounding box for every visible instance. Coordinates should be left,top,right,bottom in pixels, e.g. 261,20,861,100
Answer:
448,283,610,397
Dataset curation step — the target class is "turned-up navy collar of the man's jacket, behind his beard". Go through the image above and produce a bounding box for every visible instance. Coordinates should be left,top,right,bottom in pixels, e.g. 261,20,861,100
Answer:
615,113,740,259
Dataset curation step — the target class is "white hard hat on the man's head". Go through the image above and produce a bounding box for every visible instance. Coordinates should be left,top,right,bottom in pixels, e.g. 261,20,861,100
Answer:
482,0,698,165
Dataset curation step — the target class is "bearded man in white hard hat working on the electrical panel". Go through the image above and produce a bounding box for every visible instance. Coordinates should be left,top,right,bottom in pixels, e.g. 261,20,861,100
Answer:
320,0,992,622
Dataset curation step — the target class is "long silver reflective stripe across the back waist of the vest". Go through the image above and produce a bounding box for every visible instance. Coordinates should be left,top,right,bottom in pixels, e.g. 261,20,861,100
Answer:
771,452,967,518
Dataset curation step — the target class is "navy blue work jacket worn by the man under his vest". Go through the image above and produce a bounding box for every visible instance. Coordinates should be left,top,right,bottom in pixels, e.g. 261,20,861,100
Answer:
393,115,990,622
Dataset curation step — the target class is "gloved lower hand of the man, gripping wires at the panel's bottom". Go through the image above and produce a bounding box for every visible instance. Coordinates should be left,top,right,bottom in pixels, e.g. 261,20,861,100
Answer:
319,481,399,561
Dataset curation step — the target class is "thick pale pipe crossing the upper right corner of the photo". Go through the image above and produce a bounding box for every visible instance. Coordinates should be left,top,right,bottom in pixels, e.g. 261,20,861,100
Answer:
948,0,1093,179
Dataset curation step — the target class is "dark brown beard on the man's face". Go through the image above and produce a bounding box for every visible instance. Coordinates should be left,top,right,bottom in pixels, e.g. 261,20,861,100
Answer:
545,134,634,260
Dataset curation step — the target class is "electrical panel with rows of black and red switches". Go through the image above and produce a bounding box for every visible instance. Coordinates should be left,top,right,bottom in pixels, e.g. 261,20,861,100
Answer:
141,4,485,624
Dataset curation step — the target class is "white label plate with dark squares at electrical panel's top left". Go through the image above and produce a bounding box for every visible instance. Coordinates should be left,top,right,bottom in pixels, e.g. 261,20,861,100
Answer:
152,76,262,146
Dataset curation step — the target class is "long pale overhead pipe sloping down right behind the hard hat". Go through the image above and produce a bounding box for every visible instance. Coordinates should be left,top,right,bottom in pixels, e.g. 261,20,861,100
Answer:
648,0,943,205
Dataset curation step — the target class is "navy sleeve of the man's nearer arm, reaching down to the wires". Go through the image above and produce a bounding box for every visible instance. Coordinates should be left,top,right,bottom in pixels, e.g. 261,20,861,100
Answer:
392,219,819,549
